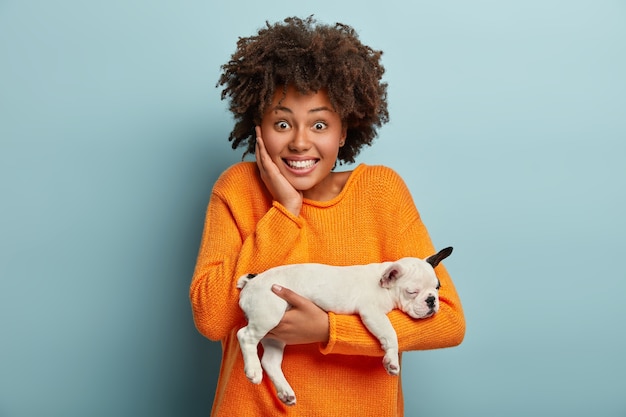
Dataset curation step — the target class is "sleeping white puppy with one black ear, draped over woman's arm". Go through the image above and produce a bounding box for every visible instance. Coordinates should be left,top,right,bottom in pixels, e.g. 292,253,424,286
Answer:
237,247,452,405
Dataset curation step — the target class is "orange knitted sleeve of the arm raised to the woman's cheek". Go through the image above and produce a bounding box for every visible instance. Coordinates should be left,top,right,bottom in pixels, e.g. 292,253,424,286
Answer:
190,161,306,340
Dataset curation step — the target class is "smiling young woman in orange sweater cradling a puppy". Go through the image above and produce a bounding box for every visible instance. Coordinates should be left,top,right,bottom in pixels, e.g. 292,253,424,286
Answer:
190,14,465,417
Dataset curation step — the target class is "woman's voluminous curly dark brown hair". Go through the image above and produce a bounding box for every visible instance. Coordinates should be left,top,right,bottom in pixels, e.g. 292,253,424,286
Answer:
217,16,389,162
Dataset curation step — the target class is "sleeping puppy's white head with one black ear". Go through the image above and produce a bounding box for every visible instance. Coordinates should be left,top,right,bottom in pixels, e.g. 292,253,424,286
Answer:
380,247,452,319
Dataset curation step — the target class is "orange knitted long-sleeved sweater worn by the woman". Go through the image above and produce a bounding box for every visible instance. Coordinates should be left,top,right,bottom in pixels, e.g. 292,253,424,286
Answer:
190,162,465,417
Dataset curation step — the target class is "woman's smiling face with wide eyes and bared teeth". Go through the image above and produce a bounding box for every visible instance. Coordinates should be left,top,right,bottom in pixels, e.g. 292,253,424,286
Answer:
261,86,346,198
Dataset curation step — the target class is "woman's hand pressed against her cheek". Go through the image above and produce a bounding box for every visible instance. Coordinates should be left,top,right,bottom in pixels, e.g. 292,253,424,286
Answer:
255,126,302,216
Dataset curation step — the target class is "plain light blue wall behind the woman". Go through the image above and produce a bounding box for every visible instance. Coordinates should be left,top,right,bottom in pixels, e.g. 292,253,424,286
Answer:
0,0,626,417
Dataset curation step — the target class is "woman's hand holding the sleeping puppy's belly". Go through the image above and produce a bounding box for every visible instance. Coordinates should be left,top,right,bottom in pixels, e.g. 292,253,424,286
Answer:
267,285,329,345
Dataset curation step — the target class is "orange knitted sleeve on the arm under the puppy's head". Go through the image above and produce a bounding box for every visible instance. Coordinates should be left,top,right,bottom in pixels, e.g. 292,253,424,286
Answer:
320,167,465,356
